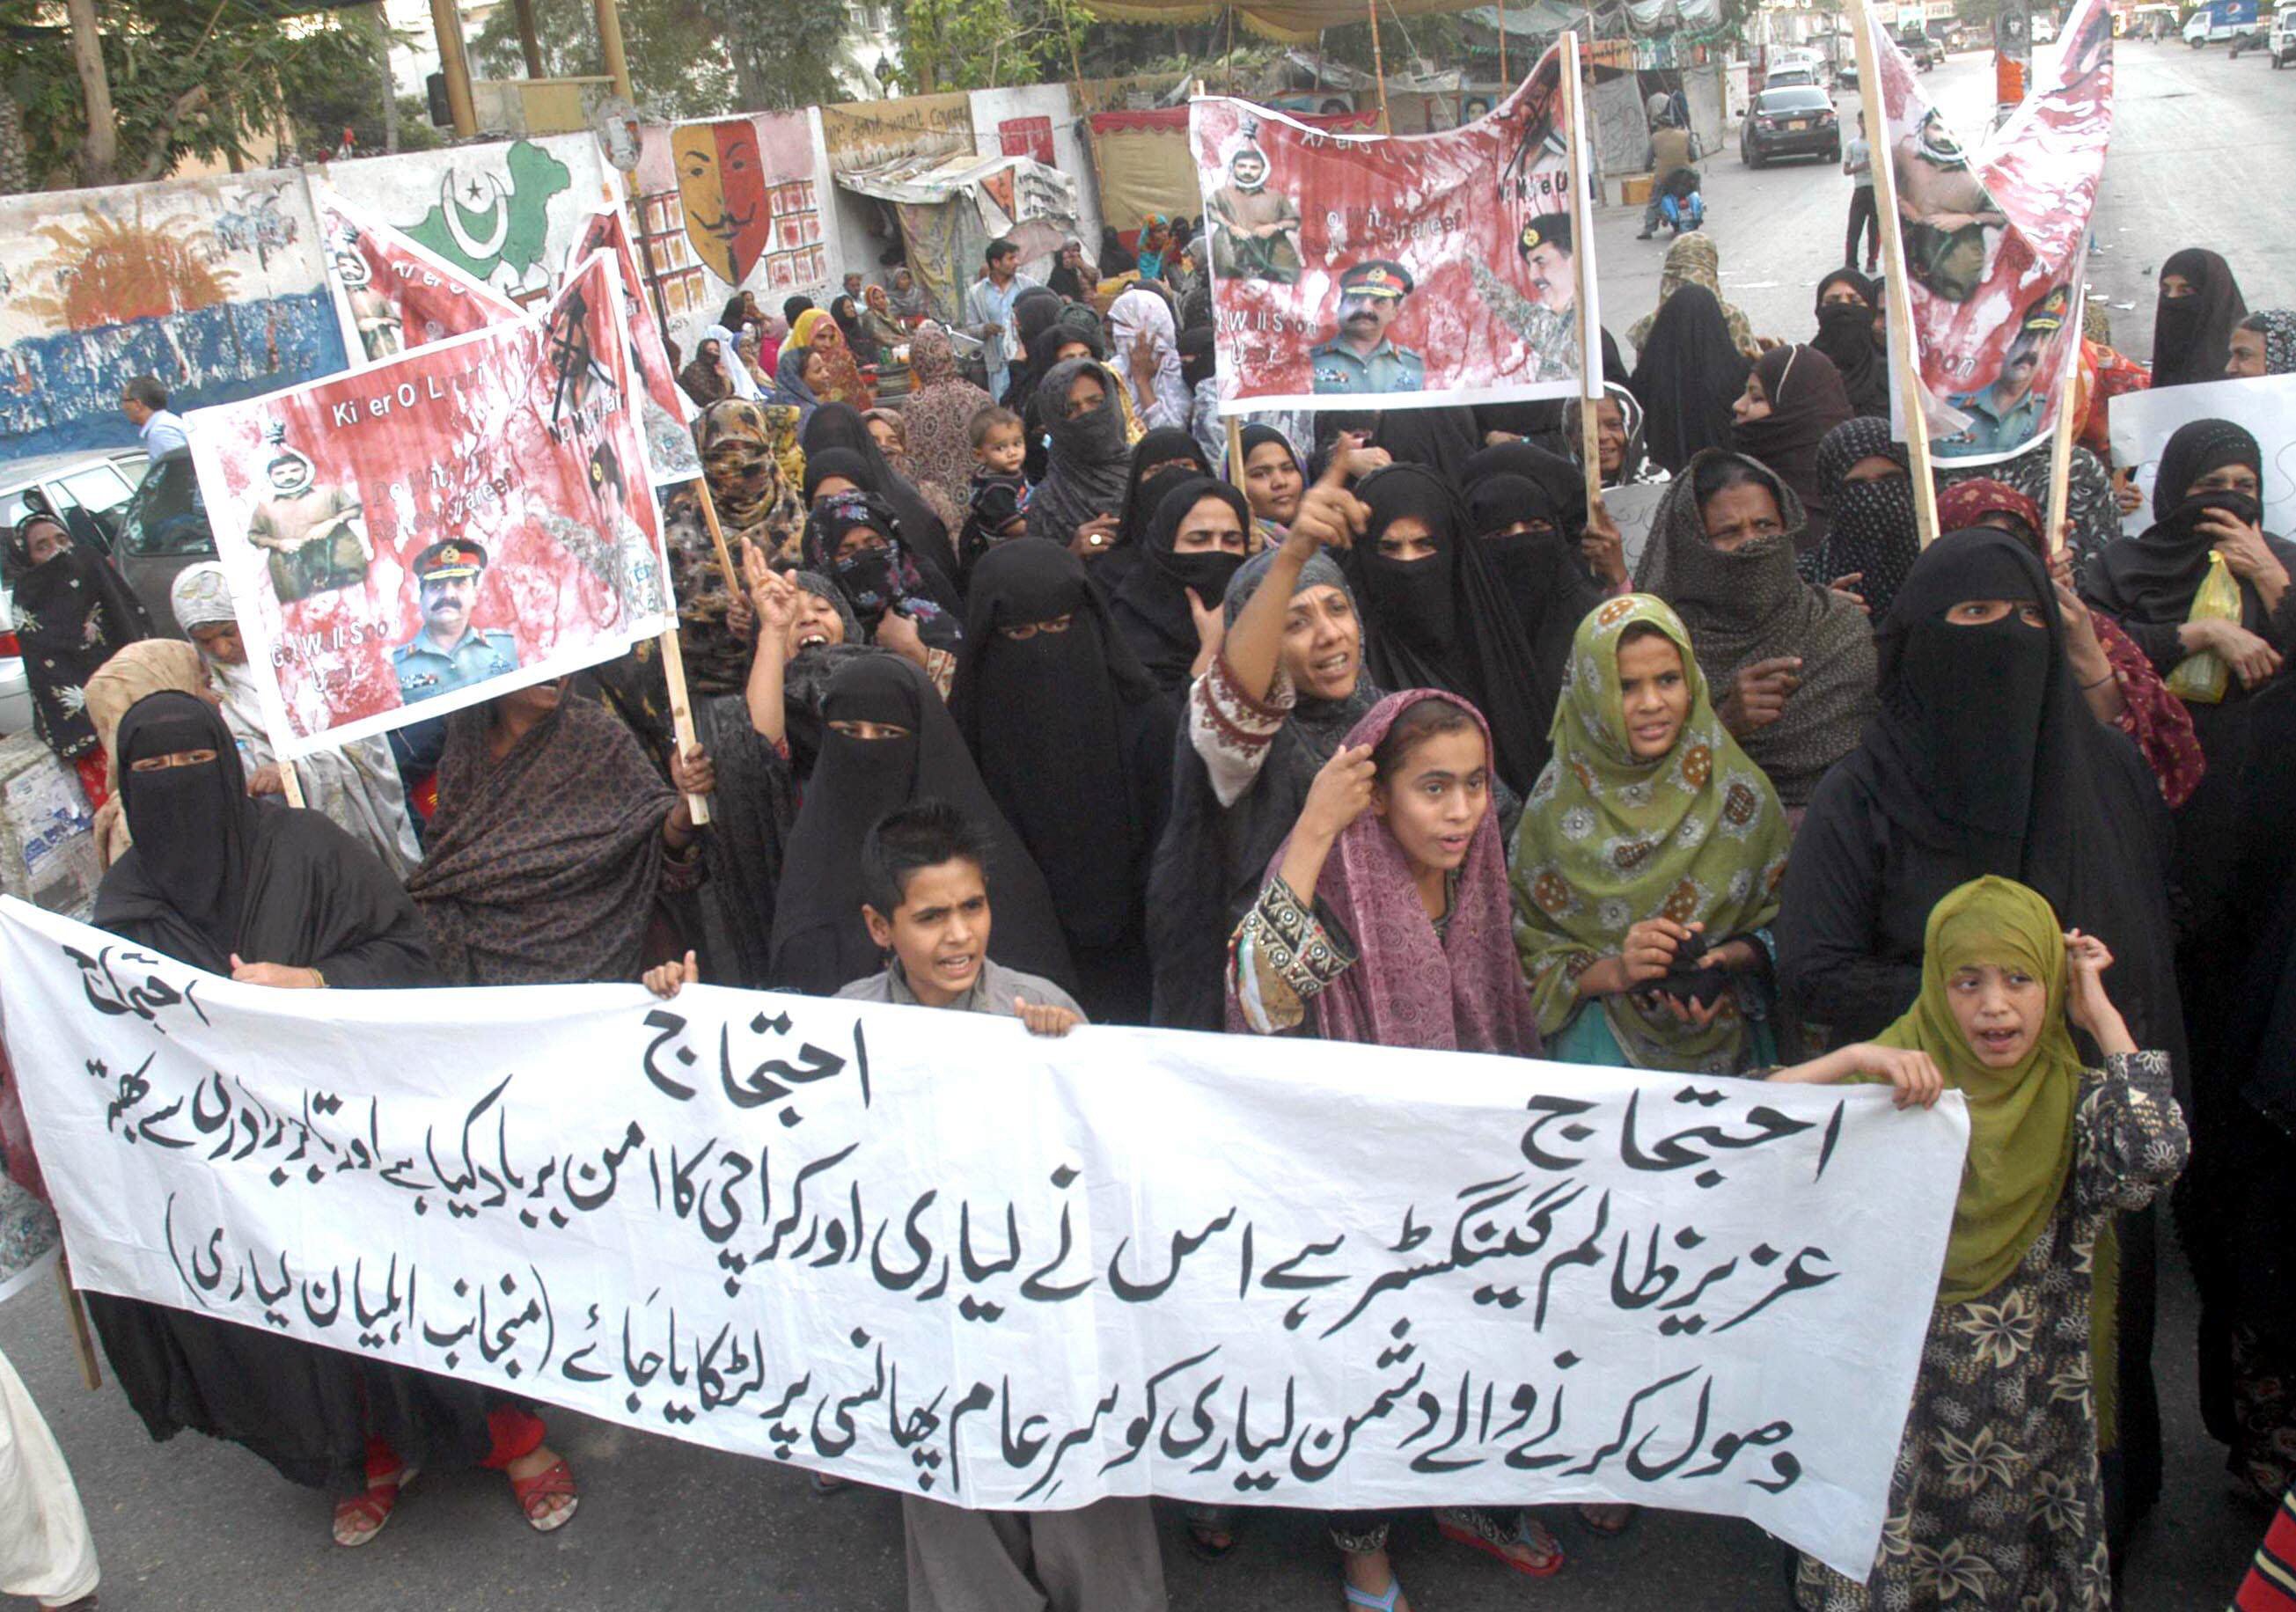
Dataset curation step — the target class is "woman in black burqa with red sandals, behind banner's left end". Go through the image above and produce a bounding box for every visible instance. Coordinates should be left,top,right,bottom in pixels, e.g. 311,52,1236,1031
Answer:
85,692,574,1545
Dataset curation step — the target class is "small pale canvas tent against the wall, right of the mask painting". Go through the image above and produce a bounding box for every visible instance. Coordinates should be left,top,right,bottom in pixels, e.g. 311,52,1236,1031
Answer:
836,151,1077,324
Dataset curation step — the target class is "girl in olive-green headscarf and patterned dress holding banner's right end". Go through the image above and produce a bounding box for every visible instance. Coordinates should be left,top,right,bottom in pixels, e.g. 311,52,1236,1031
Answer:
1771,875,2186,1612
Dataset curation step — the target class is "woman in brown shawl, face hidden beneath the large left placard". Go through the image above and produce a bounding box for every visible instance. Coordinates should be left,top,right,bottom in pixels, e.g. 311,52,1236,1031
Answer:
407,682,716,986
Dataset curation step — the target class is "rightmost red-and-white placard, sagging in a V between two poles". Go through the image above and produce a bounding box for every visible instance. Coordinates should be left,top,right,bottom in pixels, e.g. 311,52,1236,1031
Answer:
1862,0,2112,466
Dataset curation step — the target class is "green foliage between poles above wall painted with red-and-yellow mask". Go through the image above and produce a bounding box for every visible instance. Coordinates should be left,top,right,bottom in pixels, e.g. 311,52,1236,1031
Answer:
471,0,735,120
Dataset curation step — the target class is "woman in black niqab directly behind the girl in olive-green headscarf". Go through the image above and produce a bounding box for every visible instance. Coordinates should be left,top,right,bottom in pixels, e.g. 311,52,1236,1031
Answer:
1775,528,2193,1542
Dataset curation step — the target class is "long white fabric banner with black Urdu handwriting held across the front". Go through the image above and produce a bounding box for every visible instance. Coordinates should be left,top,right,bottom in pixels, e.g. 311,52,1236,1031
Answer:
0,900,1968,1578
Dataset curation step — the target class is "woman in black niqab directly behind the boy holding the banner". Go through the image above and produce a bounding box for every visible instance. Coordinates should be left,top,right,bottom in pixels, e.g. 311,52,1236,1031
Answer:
767,655,1075,997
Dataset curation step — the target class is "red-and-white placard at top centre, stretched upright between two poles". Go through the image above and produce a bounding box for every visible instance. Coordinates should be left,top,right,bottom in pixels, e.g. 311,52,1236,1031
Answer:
1189,46,1594,414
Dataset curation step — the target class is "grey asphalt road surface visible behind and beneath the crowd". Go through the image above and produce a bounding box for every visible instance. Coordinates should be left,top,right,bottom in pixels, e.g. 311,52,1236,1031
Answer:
0,44,2296,1612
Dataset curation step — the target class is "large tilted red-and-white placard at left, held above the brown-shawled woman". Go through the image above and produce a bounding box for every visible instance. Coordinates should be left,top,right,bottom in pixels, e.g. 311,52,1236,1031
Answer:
186,253,675,758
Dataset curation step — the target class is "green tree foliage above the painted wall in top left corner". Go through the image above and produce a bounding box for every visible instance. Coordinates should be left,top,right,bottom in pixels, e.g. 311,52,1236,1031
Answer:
0,0,404,184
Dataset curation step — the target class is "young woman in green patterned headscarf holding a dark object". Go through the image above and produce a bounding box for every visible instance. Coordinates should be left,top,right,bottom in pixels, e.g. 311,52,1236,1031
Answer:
1513,592,1791,1074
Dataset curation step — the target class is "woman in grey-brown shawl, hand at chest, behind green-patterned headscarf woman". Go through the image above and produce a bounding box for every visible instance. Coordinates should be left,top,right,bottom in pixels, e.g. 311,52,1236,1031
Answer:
1635,448,1876,824
